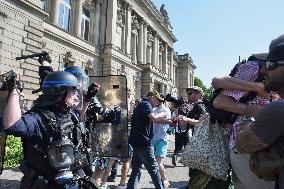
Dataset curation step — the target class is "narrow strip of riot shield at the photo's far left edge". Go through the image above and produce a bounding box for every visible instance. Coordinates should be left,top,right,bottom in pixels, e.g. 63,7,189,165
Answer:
0,72,8,175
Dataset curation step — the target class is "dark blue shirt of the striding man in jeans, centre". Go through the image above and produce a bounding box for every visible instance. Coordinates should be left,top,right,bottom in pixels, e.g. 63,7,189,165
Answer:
129,100,153,148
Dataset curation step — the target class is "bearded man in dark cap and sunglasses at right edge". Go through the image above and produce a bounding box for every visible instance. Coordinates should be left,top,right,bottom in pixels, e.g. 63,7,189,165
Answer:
236,35,284,189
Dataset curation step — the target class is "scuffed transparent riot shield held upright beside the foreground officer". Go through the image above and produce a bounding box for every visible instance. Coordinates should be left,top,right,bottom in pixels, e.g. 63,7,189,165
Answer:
87,75,128,157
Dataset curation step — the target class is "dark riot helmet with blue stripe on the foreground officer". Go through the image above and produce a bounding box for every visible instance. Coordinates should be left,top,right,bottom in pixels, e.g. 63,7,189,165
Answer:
42,71,83,109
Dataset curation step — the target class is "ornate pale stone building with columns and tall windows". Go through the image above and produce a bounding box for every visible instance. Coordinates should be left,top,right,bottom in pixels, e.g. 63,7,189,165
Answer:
0,0,196,105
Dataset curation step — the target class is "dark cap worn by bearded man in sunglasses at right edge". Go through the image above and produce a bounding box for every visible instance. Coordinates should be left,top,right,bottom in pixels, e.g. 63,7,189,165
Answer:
253,34,284,61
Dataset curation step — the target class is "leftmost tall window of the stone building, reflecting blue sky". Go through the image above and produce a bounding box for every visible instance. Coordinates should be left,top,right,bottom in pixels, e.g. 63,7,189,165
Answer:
58,0,71,31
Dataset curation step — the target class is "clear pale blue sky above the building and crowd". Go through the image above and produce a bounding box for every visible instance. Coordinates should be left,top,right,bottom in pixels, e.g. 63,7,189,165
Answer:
153,0,284,86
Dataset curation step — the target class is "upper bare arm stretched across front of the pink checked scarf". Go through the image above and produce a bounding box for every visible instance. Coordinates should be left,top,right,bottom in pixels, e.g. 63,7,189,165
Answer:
211,76,270,97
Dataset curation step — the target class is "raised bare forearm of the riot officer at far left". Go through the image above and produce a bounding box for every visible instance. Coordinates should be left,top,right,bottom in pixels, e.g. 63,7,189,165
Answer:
3,89,21,129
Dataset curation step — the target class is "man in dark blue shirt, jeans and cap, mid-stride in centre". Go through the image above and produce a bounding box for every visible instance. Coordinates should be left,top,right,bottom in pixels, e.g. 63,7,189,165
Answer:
127,91,172,189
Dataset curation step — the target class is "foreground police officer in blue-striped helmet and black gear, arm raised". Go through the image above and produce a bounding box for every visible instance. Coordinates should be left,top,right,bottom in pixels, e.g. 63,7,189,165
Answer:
3,72,97,189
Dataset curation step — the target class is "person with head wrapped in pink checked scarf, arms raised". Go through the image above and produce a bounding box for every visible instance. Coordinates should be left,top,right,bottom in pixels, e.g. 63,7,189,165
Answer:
213,56,274,189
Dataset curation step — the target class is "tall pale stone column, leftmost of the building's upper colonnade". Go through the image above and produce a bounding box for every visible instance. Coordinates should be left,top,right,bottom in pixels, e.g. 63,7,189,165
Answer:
124,3,132,54
